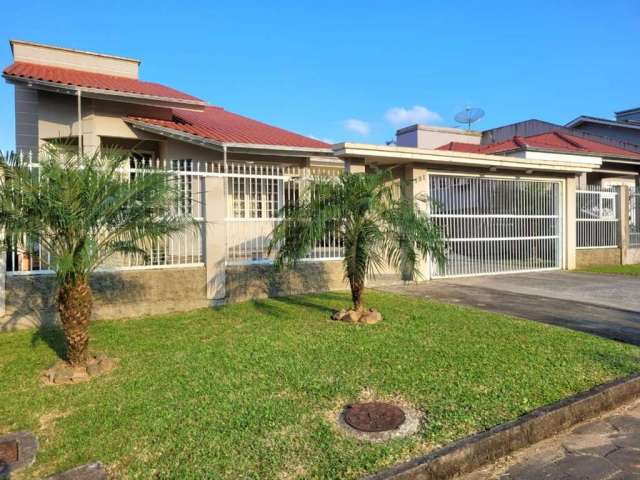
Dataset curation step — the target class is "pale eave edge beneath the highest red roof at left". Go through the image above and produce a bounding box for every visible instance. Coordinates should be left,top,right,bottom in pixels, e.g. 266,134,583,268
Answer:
2,73,207,112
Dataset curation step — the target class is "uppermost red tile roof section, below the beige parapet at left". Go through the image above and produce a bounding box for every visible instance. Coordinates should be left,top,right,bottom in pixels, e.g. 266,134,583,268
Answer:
3,62,204,106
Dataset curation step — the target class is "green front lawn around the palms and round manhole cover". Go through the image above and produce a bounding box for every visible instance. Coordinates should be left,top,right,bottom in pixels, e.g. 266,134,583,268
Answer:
0,292,640,480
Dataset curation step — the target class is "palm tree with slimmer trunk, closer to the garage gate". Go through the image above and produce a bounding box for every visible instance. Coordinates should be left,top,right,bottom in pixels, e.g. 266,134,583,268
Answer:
269,170,445,315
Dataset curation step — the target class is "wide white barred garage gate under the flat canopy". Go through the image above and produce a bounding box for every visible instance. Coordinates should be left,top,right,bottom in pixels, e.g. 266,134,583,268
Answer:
429,174,562,278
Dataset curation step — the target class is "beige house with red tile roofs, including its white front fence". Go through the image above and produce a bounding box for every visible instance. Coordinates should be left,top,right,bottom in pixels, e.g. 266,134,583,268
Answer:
0,40,345,325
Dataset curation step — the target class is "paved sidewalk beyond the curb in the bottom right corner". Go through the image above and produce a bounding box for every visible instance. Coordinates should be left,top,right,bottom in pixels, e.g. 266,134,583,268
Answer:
460,401,640,480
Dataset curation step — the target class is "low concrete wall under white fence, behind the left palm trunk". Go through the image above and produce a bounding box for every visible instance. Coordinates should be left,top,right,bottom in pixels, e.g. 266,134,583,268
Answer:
0,267,210,331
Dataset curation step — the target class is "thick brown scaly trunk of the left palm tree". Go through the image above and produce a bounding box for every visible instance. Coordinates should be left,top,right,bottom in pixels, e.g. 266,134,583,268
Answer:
58,280,93,366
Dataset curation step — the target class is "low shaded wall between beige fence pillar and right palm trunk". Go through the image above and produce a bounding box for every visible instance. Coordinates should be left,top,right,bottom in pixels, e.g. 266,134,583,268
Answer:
226,261,348,302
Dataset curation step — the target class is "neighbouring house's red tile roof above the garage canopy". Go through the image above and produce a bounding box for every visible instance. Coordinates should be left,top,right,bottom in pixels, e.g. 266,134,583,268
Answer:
437,132,640,159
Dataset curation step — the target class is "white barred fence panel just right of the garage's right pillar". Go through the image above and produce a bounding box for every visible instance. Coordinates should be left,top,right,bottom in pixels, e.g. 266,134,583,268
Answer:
576,185,619,248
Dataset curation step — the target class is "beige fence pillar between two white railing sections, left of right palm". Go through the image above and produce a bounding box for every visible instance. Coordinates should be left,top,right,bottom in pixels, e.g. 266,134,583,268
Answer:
204,177,227,302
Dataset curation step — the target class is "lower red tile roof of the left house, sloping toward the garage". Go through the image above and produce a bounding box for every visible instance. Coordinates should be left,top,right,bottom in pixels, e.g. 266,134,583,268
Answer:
129,106,330,148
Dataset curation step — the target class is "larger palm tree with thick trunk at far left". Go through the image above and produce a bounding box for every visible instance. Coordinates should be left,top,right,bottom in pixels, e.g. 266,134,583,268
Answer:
0,146,191,366
